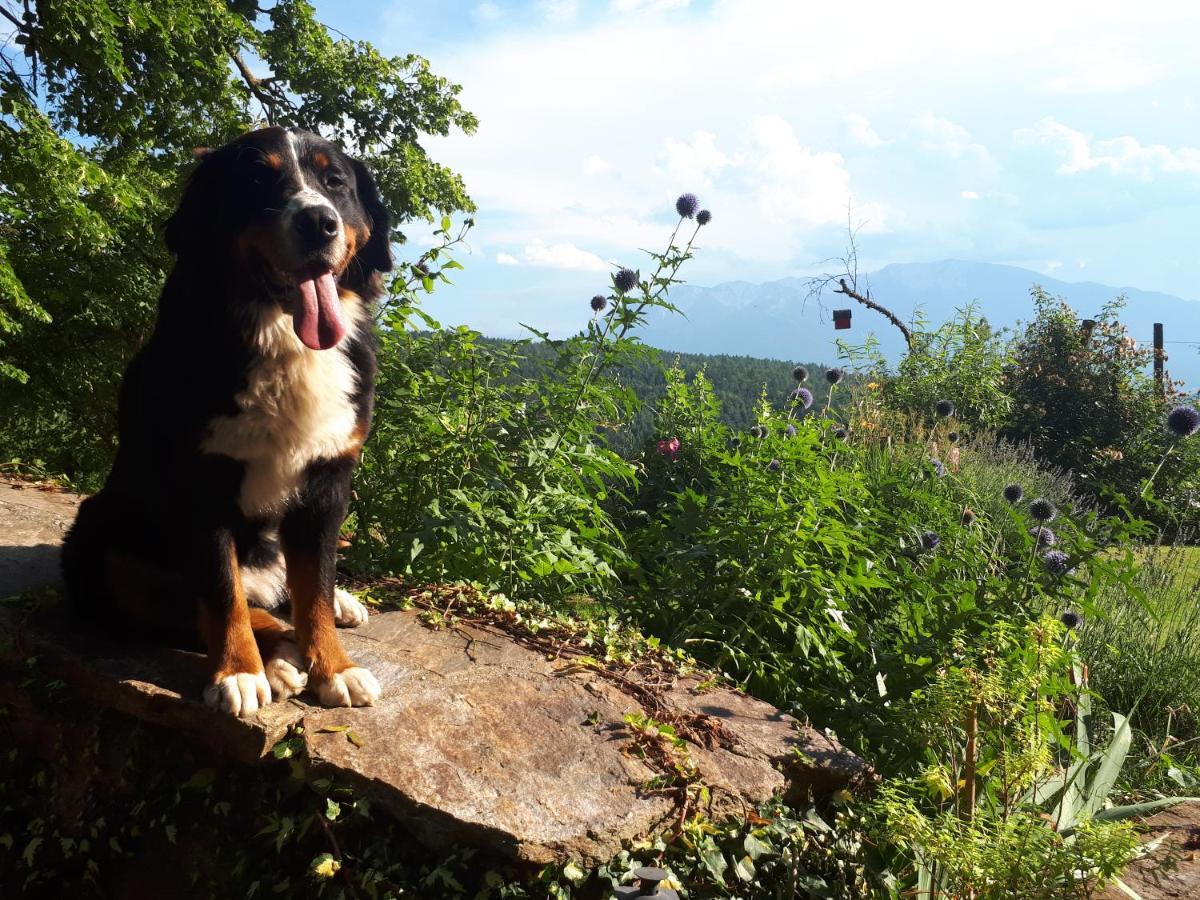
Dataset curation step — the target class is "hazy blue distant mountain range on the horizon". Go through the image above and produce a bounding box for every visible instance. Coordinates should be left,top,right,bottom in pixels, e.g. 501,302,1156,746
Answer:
642,259,1200,388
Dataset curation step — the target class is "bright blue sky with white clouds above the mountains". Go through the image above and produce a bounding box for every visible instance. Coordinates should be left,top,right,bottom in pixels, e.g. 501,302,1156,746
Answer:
317,0,1200,335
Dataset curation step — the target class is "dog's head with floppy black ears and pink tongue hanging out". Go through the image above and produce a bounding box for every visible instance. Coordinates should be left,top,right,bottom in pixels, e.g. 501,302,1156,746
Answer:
166,128,391,350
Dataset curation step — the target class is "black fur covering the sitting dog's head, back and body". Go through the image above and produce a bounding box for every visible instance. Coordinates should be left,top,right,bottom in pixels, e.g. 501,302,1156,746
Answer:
62,128,391,667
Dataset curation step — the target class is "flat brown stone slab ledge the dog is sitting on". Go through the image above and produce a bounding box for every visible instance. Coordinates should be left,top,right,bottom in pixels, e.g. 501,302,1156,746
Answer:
0,485,868,864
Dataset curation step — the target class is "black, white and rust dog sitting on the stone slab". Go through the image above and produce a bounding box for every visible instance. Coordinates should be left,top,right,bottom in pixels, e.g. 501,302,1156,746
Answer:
62,127,392,716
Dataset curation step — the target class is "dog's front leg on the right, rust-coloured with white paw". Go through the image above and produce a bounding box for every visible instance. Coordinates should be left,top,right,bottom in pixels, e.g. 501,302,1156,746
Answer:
280,457,379,707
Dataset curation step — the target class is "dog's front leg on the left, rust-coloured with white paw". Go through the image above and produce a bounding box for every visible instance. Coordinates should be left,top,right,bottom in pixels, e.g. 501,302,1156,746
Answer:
192,528,271,716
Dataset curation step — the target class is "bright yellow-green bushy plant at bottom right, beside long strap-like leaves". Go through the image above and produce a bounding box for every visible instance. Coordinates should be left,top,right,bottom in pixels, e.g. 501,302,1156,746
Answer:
875,617,1138,900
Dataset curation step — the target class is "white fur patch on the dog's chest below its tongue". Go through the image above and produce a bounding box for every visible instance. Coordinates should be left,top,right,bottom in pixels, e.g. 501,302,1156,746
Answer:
202,301,359,517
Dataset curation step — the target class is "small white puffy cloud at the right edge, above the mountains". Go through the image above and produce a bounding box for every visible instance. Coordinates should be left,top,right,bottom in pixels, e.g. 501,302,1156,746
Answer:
1013,118,1200,181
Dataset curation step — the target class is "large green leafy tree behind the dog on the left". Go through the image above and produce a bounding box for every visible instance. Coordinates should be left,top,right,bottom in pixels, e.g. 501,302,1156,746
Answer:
0,0,475,487
